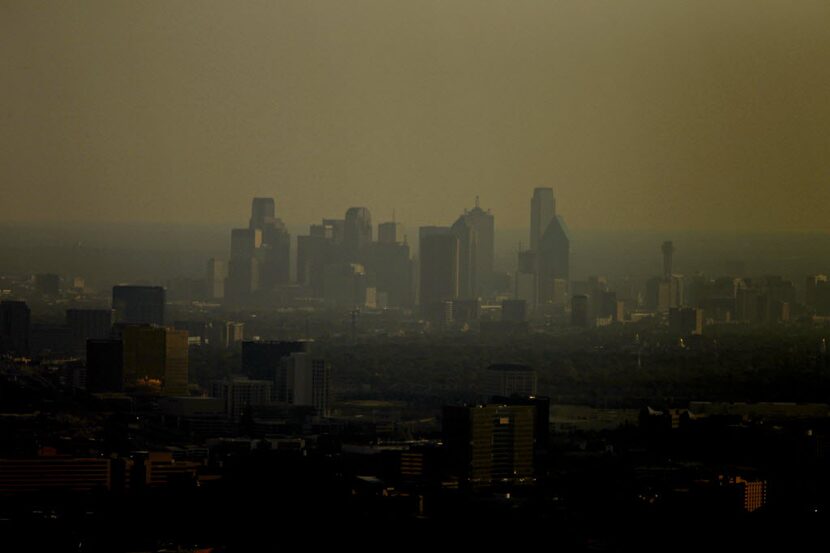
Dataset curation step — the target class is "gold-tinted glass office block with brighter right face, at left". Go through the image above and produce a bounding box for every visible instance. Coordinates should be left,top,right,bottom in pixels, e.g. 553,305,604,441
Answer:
122,325,188,396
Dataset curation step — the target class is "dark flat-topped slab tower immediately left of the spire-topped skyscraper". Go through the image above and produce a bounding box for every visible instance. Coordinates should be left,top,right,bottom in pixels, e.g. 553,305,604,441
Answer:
419,227,460,306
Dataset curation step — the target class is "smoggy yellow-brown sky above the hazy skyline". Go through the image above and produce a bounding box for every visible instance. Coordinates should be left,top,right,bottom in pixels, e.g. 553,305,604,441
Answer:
0,0,830,231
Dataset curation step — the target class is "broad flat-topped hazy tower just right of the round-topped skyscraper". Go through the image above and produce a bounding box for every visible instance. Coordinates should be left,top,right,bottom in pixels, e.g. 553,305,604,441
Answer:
368,239,412,307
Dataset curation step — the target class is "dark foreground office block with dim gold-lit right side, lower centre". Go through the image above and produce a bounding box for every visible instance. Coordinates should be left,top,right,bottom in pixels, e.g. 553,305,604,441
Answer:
442,404,536,487
